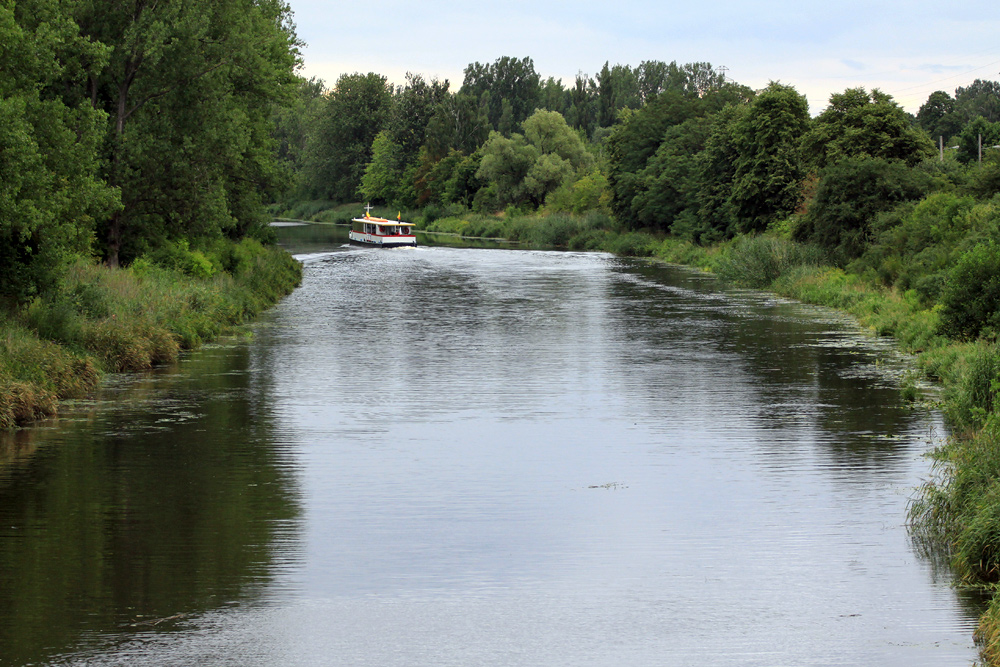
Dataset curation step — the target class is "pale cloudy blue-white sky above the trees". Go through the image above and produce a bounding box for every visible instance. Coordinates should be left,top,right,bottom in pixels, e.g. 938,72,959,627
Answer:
289,0,1000,115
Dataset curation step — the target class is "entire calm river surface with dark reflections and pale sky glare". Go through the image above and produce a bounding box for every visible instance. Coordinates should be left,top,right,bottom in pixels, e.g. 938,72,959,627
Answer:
0,228,977,667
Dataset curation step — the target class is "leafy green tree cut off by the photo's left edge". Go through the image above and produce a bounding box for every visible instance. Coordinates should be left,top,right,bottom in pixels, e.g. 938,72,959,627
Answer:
0,0,118,303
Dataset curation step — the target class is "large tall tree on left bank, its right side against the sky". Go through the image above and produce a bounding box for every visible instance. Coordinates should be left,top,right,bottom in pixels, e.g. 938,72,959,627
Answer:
67,0,298,266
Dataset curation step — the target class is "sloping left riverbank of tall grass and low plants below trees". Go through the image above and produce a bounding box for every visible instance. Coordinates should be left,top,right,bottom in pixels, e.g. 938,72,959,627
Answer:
0,239,301,428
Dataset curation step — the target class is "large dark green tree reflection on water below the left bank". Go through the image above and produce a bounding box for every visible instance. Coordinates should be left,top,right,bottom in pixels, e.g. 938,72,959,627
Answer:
0,347,299,664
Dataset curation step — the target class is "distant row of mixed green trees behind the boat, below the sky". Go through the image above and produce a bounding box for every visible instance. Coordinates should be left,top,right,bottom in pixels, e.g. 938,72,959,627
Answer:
276,57,1000,262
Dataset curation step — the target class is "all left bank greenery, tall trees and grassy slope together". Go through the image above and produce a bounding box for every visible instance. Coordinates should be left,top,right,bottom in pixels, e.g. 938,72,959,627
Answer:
0,0,299,428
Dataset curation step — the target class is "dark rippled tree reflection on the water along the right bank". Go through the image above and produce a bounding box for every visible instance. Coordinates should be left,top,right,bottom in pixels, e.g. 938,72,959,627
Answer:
600,263,914,473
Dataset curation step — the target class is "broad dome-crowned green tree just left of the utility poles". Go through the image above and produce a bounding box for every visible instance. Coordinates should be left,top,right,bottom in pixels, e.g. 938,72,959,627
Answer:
802,88,935,169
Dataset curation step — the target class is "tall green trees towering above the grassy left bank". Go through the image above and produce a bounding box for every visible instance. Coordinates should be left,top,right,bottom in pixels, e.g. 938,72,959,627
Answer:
0,0,299,304
